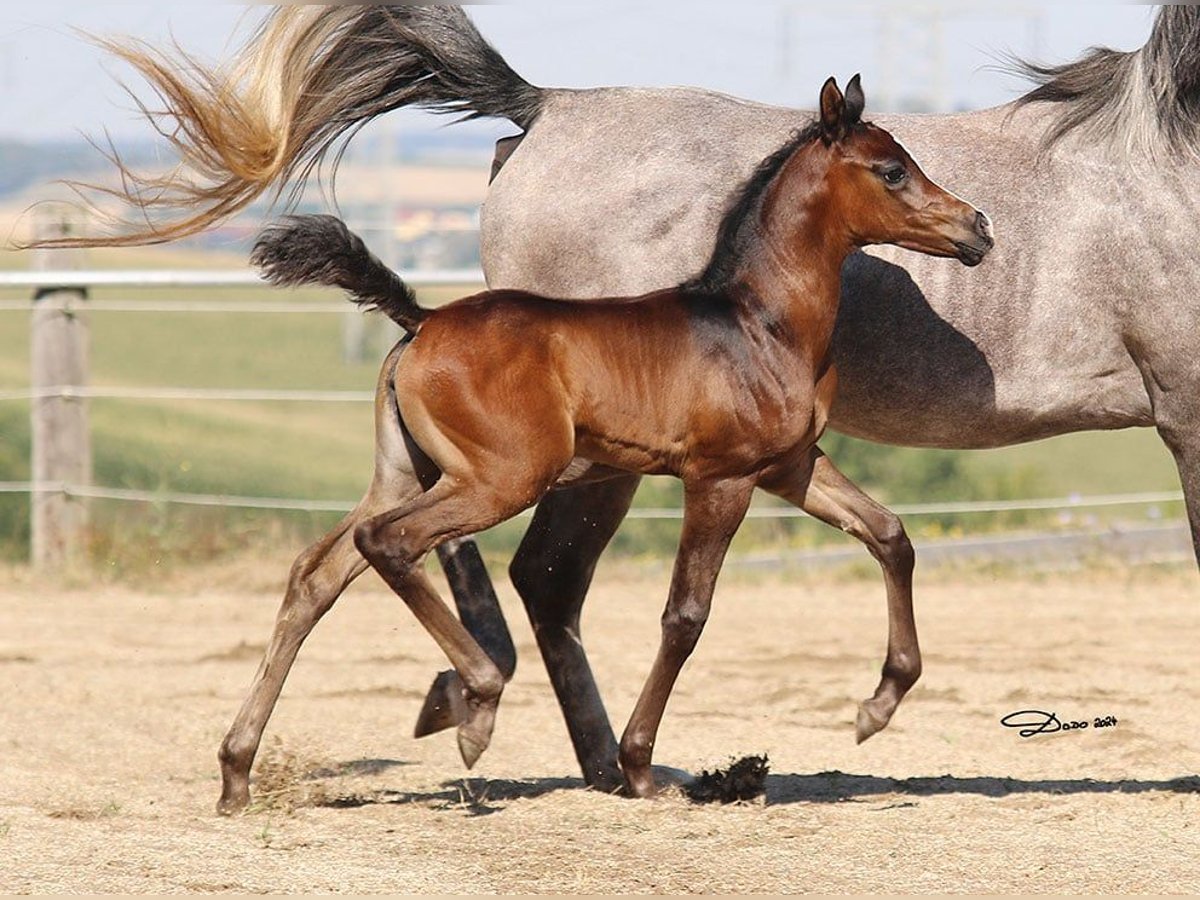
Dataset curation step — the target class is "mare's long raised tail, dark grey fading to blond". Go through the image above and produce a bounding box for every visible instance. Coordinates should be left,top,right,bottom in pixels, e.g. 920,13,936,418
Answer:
28,5,545,246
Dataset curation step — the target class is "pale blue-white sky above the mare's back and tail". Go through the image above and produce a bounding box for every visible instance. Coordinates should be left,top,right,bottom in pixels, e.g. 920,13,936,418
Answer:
0,1,1153,138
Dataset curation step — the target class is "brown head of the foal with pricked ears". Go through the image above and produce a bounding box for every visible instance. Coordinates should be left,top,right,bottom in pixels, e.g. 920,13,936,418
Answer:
782,76,992,265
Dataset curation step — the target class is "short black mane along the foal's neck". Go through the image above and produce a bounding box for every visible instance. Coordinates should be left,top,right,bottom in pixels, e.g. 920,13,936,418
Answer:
679,120,835,294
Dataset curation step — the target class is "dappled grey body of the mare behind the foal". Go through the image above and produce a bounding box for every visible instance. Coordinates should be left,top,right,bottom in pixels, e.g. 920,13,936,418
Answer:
482,98,1156,451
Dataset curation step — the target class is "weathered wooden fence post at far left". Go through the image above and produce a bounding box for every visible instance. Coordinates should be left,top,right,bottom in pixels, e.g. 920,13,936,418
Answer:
30,217,91,571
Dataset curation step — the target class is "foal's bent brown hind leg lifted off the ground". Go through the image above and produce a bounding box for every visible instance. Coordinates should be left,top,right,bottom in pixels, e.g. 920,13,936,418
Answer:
354,475,549,768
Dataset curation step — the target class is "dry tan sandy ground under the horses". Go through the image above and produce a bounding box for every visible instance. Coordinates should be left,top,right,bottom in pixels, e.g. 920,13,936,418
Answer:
0,564,1200,893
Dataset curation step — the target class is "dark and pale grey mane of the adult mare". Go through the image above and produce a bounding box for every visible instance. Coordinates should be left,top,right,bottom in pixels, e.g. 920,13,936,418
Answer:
1014,6,1200,158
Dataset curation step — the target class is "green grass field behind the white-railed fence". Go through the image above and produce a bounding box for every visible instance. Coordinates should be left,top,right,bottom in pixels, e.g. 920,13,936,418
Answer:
0,247,1181,571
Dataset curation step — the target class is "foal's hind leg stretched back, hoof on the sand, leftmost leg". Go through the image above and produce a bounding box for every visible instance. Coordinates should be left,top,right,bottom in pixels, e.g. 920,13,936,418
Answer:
217,481,420,815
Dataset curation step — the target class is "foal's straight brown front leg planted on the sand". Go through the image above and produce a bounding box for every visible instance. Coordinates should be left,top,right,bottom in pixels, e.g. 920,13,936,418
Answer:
620,479,754,797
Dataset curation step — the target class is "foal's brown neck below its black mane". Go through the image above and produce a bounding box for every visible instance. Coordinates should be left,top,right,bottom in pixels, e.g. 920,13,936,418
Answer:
732,158,856,371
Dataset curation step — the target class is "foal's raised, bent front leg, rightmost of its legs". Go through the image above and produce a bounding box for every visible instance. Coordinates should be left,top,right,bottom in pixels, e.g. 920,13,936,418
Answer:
760,448,920,743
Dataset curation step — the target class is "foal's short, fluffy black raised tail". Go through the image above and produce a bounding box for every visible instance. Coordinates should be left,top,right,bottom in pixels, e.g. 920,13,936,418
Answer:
250,216,430,334
